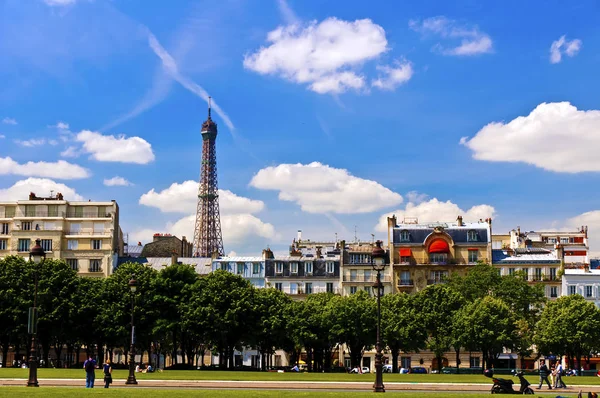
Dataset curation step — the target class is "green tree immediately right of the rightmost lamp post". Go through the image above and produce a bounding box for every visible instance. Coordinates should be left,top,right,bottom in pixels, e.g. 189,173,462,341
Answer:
381,293,427,373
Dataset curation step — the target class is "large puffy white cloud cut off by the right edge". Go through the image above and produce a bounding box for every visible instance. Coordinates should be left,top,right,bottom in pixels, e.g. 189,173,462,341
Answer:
461,102,600,173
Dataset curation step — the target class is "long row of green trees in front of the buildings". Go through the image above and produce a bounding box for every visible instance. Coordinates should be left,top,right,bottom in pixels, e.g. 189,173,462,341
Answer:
0,257,600,371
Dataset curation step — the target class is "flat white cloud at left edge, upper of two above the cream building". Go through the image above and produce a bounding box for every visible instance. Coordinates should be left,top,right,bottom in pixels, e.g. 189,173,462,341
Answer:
0,157,90,180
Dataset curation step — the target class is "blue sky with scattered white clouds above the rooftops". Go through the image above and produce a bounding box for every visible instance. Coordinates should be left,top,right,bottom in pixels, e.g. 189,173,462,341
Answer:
0,0,600,254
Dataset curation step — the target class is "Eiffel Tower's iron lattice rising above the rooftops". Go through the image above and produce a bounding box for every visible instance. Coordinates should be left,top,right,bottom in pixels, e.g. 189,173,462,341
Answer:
194,97,225,257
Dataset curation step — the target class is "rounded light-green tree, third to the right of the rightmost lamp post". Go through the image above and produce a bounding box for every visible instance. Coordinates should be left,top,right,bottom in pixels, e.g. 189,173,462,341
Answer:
453,296,516,368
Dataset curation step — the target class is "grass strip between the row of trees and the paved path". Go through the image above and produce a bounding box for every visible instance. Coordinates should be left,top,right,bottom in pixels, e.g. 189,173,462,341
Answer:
0,368,600,386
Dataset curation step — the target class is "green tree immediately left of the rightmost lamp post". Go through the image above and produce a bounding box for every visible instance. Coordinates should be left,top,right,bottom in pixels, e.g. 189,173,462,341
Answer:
331,291,377,368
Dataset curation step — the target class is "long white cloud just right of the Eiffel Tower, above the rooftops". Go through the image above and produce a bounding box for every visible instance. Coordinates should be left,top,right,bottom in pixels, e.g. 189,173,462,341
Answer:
250,162,402,214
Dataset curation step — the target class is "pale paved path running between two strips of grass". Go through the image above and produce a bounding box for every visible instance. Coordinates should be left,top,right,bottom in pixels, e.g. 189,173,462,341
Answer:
0,378,600,394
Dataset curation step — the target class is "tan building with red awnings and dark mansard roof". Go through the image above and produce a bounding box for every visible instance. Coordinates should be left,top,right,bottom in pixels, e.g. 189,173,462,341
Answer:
388,216,492,292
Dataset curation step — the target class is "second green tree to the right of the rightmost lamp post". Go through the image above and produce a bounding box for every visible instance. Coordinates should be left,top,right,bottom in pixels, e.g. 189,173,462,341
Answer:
416,284,464,371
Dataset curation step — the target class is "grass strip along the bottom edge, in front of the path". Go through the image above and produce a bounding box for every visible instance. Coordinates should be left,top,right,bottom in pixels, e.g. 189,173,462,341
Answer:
0,387,576,398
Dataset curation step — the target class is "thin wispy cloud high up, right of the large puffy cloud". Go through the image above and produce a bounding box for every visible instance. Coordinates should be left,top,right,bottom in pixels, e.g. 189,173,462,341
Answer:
408,16,493,56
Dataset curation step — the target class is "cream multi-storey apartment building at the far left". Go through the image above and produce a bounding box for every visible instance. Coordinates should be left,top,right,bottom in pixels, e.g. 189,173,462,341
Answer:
0,193,123,277
